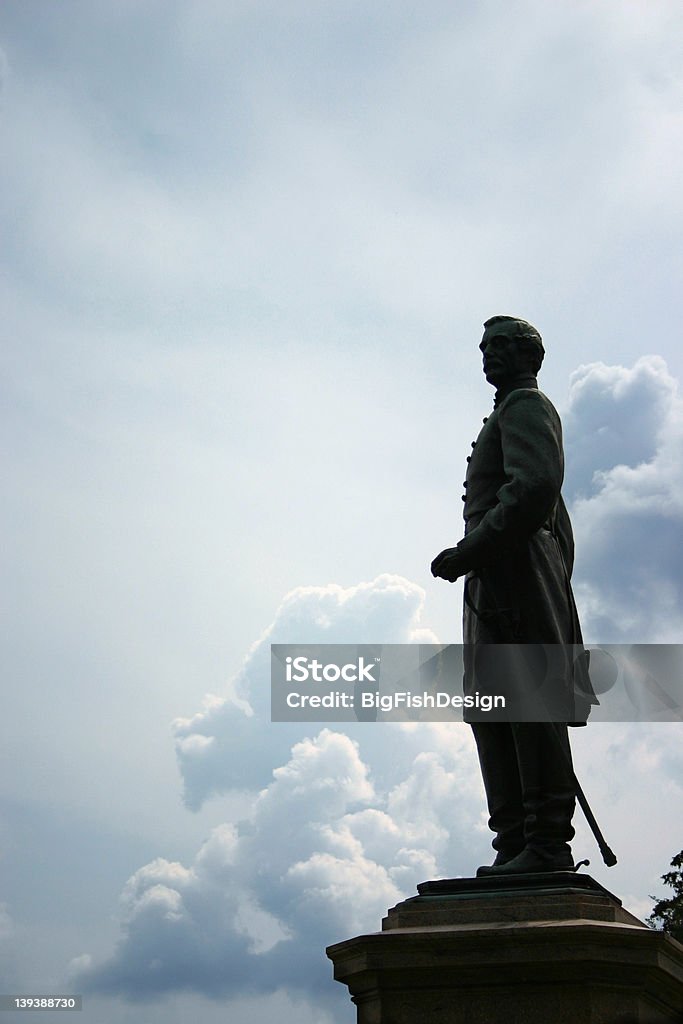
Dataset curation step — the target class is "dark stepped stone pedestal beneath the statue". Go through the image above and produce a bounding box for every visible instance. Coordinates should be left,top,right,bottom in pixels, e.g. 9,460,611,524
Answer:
327,871,683,1024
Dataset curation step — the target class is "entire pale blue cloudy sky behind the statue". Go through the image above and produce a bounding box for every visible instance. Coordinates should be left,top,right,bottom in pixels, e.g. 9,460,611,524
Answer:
0,0,683,1024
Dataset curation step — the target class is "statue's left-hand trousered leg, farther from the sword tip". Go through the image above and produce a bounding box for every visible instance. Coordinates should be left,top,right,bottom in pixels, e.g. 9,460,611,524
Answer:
471,722,525,864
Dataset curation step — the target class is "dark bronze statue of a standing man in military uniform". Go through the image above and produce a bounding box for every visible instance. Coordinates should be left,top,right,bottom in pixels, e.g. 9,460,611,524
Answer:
431,316,595,874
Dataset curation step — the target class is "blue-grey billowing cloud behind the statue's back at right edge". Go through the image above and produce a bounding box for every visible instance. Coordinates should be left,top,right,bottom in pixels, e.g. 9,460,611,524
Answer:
565,355,683,643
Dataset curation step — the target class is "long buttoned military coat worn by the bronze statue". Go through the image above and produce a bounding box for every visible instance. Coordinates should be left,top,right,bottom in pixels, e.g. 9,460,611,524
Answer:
458,382,596,724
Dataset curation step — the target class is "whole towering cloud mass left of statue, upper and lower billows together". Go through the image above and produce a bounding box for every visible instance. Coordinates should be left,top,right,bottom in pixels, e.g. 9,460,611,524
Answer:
72,575,485,1000
